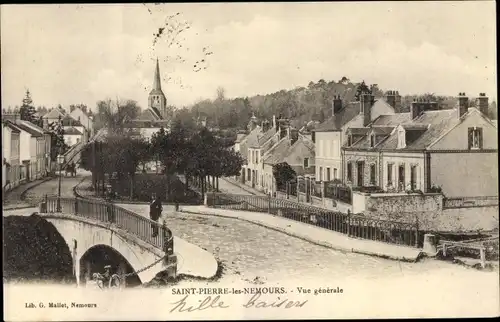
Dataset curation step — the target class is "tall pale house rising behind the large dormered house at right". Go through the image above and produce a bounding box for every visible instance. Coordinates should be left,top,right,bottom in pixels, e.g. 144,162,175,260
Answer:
312,91,401,181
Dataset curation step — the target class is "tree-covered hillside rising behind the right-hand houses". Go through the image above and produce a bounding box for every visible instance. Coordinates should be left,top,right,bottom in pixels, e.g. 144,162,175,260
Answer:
172,77,496,129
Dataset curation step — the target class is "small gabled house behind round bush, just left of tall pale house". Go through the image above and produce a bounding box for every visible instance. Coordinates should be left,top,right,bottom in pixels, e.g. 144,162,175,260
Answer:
262,127,315,195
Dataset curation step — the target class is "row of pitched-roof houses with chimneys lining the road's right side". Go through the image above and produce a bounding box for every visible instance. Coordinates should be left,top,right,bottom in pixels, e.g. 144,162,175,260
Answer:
235,91,498,197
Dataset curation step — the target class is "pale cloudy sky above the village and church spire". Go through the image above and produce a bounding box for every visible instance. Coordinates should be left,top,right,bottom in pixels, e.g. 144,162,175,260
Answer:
0,1,497,109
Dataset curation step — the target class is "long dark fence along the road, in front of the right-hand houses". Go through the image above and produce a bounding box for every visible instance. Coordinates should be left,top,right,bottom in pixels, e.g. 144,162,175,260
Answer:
207,193,422,247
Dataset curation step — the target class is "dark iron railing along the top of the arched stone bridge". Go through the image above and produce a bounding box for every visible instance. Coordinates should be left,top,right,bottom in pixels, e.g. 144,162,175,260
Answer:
40,197,174,255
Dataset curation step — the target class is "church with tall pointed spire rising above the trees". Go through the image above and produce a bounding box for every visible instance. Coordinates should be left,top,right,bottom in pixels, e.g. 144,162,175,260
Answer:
125,59,171,140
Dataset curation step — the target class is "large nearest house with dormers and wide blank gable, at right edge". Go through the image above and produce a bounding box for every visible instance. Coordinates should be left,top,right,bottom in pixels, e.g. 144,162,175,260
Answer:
343,93,498,197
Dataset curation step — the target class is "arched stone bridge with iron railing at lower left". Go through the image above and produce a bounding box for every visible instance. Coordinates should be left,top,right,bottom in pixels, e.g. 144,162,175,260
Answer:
5,198,177,286
